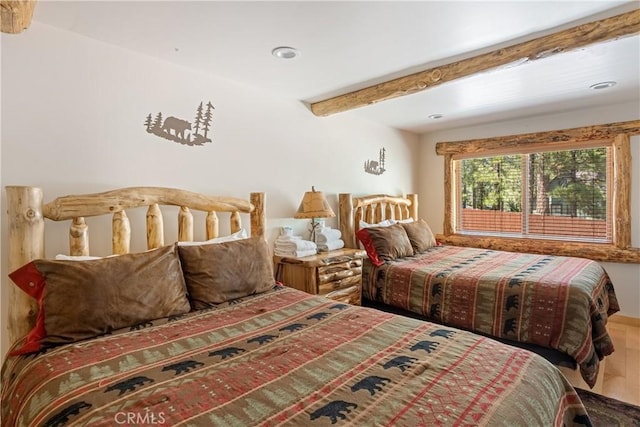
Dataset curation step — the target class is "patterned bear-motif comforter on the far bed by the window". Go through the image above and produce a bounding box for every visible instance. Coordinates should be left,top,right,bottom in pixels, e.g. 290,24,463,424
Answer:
363,246,620,387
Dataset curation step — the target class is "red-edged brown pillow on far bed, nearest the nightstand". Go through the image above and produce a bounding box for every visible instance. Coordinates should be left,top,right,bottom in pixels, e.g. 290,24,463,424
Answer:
356,224,413,266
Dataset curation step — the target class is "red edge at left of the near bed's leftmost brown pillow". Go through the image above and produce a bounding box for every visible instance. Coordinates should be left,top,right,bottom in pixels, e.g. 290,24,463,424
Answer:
9,261,47,356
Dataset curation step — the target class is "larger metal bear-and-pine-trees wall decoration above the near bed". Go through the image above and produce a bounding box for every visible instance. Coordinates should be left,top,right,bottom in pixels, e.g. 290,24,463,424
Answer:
144,101,215,145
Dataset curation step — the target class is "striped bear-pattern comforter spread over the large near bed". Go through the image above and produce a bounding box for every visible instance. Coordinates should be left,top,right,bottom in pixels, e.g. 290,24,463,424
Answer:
2,288,589,427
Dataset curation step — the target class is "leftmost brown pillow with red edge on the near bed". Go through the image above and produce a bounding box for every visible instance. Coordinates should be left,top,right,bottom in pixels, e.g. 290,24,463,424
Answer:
9,245,190,355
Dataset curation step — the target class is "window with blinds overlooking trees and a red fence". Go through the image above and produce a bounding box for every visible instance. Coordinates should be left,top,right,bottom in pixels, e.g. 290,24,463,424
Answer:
454,144,612,243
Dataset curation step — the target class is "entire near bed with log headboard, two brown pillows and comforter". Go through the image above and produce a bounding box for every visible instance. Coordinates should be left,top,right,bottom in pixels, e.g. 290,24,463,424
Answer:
1,187,590,427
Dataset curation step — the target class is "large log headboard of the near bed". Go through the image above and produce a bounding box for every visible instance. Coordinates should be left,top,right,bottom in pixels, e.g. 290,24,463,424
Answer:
6,186,266,350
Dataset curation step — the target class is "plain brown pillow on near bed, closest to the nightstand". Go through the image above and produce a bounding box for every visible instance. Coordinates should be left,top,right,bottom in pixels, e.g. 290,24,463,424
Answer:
178,237,275,310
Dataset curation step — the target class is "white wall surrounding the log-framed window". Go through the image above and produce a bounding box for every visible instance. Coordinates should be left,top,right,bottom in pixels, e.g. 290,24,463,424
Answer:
416,103,640,318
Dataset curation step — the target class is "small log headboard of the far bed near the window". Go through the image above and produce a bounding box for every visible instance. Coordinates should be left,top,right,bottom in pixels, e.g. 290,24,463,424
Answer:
338,193,418,248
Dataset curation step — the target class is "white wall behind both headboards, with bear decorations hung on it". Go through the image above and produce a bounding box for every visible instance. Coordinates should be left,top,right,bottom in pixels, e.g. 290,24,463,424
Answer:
0,22,418,362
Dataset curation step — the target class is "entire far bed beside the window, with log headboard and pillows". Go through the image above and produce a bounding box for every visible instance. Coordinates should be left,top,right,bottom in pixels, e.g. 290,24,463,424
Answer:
339,193,619,387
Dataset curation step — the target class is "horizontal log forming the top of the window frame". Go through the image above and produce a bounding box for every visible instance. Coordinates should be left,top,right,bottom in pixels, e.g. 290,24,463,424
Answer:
436,120,640,155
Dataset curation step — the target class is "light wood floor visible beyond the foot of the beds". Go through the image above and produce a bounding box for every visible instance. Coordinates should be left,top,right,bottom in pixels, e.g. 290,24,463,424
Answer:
562,315,640,406
